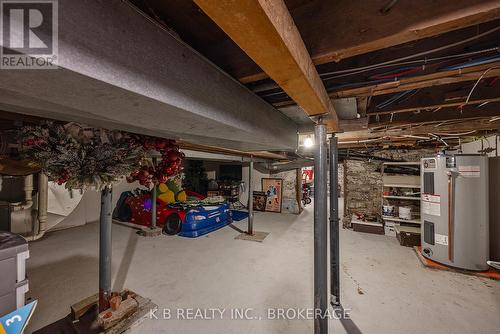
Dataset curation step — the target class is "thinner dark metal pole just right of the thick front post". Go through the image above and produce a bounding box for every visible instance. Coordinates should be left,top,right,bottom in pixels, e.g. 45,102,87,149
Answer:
329,134,340,306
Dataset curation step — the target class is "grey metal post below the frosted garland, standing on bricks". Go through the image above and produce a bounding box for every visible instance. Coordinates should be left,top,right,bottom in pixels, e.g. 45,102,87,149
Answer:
99,186,113,312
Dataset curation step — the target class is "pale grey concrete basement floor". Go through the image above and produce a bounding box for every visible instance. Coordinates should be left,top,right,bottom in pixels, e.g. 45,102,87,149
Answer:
27,200,500,334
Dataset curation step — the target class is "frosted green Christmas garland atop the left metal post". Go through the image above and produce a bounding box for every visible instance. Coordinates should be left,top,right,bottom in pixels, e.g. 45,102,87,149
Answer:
20,122,145,189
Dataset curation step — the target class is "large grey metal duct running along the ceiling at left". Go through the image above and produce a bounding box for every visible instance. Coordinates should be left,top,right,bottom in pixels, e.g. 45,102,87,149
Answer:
0,0,297,150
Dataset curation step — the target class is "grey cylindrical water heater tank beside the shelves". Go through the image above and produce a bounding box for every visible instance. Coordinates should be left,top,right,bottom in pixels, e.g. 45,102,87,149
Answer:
420,154,489,271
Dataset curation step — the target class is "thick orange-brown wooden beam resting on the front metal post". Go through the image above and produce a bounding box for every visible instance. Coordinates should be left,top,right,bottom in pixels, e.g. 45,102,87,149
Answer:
194,0,337,128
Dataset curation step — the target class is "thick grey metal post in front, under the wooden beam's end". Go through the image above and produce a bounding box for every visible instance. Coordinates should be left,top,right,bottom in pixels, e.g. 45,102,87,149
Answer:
314,119,328,334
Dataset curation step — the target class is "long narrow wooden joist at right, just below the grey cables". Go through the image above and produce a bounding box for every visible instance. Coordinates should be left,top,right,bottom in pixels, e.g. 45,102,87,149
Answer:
329,62,500,98
